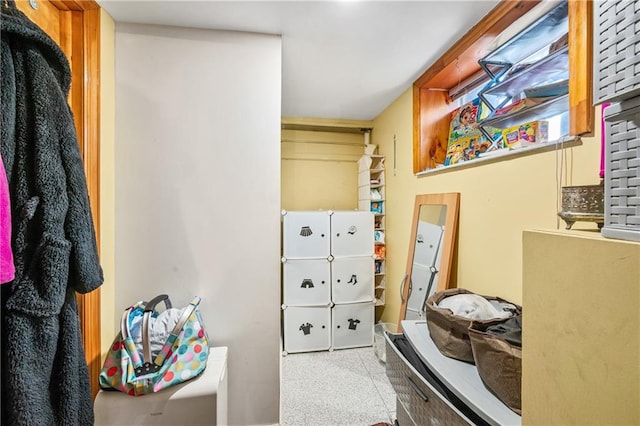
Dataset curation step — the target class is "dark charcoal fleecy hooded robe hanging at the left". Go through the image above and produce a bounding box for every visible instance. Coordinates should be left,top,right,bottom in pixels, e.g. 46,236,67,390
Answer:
0,0,103,425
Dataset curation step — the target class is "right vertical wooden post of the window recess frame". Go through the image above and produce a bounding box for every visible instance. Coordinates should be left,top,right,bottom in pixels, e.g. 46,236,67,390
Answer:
569,0,595,136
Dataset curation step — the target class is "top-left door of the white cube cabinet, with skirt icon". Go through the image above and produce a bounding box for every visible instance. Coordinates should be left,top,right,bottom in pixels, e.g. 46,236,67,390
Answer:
282,211,331,259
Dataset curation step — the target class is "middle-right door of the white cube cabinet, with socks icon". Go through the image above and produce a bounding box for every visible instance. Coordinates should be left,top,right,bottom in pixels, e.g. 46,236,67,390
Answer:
331,257,374,303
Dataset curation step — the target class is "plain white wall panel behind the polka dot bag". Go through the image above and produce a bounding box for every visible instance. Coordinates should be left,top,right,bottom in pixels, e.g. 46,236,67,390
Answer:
114,24,281,425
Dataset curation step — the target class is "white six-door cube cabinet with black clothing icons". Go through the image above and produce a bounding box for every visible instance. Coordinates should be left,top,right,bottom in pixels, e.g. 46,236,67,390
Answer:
282,211,375,353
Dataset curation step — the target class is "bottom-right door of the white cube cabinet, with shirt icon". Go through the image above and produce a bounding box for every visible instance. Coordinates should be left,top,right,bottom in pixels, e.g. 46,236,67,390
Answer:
331,302,374,349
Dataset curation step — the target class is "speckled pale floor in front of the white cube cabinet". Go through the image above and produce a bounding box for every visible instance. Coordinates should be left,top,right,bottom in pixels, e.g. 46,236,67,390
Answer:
280,347,396,426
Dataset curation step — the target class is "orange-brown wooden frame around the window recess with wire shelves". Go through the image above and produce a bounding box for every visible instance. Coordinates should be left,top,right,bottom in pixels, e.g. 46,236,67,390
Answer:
413,0,595,174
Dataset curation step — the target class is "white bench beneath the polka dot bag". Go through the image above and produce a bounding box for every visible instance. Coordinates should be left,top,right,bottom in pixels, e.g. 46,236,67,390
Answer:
93,346,227,426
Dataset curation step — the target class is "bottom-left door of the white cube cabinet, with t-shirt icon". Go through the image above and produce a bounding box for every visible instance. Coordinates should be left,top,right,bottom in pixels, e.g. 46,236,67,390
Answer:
284,306,331,353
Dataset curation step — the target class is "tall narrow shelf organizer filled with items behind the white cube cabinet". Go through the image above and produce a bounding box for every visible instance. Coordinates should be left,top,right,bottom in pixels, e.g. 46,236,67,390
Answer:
358,154,386,306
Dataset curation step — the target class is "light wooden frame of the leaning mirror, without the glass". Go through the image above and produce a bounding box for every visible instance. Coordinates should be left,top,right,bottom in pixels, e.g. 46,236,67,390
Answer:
398,192,460,333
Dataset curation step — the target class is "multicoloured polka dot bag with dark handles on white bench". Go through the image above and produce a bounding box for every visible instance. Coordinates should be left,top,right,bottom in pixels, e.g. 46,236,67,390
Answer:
99,294,209,396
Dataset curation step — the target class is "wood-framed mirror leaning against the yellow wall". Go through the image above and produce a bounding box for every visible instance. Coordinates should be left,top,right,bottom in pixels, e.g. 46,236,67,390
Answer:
398,192,460,331
